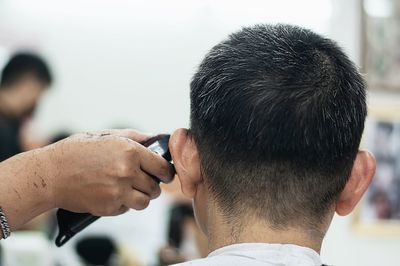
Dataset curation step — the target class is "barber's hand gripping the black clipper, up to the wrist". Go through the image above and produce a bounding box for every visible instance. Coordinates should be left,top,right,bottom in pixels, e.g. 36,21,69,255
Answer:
45,130,173,216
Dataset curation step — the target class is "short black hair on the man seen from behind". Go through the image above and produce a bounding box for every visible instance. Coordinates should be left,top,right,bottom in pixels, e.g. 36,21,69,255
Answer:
190,24,367,229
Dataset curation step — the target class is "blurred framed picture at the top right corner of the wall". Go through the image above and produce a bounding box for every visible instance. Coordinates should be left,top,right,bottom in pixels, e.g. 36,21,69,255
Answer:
362,0,400,93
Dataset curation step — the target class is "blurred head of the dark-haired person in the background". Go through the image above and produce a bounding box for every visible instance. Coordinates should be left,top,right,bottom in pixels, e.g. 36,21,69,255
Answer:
0,53,52,118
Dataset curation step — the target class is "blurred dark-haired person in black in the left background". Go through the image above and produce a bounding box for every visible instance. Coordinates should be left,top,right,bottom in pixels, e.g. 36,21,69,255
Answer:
0,52,52,161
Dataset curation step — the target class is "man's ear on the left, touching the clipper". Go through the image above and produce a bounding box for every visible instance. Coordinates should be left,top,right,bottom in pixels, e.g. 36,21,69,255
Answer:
169,128,203,198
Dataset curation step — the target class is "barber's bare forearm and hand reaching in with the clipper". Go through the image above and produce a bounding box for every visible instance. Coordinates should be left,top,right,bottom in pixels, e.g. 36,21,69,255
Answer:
0,130,173,238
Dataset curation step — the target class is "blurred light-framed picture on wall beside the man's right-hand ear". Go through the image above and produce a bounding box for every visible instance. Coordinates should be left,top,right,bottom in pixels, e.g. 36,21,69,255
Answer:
354,106,400,236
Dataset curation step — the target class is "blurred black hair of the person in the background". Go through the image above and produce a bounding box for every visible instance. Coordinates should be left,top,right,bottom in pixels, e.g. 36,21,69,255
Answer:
0,52,52,87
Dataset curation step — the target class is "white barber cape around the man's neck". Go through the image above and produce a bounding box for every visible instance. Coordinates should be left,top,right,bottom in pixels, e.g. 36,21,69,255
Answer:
175,243,322,266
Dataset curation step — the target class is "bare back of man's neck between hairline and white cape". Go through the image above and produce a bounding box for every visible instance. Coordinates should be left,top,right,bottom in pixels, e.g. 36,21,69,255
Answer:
207,204,325,253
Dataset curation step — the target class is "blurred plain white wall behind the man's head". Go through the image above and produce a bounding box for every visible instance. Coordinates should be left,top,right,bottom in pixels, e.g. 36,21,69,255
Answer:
0,0,400,266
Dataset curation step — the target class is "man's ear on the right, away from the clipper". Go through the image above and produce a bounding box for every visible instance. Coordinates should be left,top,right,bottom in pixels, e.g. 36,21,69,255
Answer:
336,151,376,216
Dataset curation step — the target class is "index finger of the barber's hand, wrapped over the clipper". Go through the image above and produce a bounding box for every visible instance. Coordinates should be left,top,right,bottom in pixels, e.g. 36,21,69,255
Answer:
137,144,175,183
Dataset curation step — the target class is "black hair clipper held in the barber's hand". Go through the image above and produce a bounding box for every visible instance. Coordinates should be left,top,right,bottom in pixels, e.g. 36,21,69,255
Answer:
55,134,175,247
